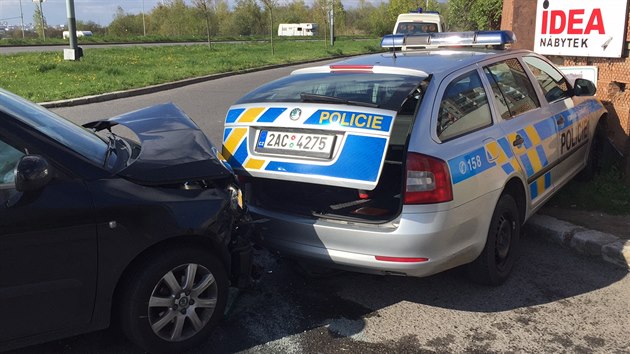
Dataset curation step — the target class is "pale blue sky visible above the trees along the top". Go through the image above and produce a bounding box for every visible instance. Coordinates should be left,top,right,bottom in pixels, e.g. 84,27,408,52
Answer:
0,0,380,26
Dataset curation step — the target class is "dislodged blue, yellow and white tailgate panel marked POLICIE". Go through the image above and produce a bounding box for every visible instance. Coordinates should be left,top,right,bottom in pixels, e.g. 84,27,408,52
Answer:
223,103,396,190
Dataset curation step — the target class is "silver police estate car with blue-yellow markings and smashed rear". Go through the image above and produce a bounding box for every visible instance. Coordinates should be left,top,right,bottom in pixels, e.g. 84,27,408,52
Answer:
223,31,606,285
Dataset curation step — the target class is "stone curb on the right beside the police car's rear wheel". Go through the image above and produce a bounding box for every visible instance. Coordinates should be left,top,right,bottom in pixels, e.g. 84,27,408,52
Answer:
525,214,630,269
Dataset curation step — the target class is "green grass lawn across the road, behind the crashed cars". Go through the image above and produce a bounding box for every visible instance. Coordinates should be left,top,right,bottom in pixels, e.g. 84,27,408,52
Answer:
0,39,380,102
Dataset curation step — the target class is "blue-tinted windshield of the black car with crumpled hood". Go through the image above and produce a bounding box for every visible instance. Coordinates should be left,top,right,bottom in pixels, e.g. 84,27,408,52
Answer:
0,89,107,165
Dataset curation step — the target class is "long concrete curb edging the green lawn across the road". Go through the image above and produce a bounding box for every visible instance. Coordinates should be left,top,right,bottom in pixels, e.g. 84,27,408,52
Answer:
39,55,354,108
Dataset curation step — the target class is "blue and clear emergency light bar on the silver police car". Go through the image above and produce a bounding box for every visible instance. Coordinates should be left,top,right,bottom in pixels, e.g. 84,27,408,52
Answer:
381,31,516,50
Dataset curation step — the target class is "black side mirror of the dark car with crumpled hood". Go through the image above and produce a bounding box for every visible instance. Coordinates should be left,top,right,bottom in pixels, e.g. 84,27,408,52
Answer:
15,155,52,192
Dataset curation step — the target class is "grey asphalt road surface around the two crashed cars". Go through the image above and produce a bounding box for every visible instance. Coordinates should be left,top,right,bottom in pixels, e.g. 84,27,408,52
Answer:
9,62,630,353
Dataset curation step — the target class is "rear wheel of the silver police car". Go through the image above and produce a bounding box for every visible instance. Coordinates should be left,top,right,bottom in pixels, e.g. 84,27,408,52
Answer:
467,194,521,286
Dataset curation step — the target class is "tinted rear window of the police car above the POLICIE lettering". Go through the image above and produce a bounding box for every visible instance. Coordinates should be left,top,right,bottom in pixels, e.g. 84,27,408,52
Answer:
236,73,424,111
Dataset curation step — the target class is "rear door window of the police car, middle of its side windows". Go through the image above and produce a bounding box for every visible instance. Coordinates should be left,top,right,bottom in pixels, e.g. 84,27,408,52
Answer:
484,59,540,119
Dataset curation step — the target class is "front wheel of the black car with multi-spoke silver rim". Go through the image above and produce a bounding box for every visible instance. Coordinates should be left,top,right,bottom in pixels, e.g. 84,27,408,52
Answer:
114,248,229,353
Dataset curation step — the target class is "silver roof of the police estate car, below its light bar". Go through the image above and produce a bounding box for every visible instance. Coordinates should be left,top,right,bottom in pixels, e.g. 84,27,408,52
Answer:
320,48,513,74
